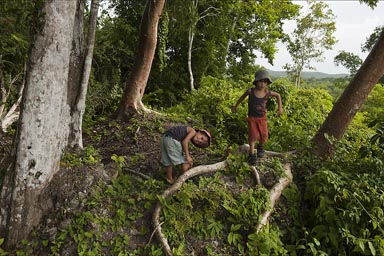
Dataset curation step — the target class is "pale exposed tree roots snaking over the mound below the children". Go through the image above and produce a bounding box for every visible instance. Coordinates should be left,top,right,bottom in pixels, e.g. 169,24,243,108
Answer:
152,145,292,256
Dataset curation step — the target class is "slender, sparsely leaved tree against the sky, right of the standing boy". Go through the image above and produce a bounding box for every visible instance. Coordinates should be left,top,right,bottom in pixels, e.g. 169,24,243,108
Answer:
284,0,337,87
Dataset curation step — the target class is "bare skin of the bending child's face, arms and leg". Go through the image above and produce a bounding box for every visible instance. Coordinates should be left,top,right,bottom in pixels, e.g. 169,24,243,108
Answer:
165,127,209,183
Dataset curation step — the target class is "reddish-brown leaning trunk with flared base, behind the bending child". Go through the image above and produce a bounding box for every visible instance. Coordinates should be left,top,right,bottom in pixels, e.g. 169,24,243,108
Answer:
117,0,165,119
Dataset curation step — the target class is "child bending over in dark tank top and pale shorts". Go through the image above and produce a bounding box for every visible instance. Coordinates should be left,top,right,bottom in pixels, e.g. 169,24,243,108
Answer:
160,126,211,184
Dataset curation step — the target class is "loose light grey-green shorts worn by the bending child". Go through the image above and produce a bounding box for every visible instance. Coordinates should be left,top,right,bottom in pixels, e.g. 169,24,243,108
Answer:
160,135,187,166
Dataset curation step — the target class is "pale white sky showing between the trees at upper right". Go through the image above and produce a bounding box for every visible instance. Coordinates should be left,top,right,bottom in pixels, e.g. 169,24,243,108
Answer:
256,0,384,74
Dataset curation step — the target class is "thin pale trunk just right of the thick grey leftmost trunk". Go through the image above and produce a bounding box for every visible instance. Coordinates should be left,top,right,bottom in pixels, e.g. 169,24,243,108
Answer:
69,0,99,148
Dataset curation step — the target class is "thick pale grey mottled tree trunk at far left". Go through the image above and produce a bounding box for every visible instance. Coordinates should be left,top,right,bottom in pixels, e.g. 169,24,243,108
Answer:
0,0,80,247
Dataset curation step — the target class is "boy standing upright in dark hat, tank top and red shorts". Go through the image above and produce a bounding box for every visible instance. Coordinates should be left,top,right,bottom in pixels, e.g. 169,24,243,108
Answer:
231,70,283,165
